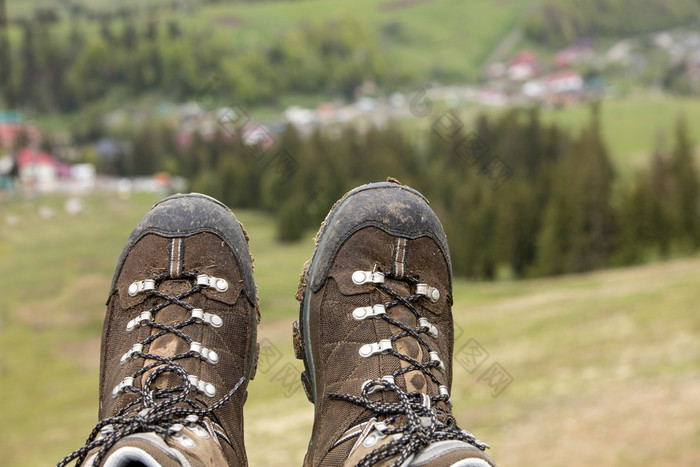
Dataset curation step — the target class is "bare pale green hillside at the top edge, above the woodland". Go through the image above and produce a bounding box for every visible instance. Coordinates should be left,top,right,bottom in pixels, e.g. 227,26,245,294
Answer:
197,0,532,80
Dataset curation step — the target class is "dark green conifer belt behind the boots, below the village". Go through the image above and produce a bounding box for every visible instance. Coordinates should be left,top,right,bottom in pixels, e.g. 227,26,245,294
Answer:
95,107,700,279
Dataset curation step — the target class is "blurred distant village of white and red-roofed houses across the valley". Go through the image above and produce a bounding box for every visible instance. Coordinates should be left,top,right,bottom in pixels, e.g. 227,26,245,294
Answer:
0,27,700,194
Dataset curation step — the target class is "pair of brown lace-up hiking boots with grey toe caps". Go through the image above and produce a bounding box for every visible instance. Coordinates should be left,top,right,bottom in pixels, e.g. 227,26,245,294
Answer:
59,181,495,467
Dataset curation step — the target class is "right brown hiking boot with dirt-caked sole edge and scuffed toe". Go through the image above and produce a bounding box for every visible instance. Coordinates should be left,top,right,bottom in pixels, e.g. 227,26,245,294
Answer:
294,182,495,467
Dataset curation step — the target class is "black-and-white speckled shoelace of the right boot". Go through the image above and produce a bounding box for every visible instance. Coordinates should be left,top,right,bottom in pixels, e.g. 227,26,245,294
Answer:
328,273,489,467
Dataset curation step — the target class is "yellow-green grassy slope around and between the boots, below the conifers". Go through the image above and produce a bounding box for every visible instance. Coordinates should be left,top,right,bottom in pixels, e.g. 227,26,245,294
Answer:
0,195,700,466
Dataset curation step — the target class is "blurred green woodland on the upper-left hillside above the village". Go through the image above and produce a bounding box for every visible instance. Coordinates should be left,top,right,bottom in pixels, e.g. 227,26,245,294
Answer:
5,10,405,112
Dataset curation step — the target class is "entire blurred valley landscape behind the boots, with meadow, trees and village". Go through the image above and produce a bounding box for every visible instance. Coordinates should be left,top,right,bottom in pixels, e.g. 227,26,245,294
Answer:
0,0,700,466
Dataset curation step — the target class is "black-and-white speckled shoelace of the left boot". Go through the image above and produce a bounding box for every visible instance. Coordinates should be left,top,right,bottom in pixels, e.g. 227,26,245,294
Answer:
57,272,245,467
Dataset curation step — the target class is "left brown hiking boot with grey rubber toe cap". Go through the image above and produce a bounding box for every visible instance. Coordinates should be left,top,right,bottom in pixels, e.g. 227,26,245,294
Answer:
59,194,259,467
